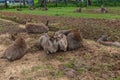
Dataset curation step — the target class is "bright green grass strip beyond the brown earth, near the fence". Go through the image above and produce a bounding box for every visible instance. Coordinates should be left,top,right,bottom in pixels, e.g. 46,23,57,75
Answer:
1,7,120,19
